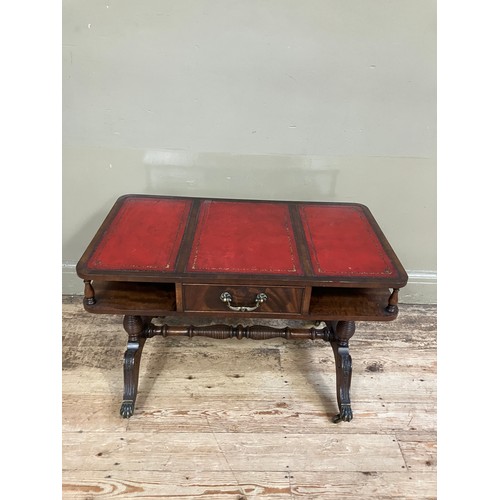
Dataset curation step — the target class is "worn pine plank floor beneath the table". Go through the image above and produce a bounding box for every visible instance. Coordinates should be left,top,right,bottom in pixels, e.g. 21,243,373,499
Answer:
62,297,437,500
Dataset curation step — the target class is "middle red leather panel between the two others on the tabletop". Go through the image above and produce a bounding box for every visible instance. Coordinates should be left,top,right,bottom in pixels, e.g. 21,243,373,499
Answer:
187,200,303,275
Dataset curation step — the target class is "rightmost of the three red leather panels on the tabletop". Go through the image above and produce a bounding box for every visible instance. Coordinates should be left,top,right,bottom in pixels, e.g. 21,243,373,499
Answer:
299,205,396,277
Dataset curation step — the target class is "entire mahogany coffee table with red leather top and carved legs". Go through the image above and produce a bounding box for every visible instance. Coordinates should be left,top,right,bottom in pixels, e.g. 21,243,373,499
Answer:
77,195,408,421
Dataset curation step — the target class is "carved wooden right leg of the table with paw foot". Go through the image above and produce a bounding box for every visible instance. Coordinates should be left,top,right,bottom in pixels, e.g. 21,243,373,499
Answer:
327,321,356,423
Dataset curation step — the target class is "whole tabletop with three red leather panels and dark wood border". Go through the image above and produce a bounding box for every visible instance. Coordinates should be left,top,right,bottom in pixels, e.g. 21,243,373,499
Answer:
77,195,407,286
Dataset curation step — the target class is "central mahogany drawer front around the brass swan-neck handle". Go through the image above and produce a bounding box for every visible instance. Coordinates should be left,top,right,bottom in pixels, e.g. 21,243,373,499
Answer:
183,285,304,315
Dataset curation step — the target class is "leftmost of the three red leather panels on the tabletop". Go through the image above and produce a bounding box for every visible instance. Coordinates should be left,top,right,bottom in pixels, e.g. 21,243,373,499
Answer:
88,198,191,272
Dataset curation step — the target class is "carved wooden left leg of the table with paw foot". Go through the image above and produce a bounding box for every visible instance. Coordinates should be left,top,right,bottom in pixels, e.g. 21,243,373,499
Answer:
120,316,147,418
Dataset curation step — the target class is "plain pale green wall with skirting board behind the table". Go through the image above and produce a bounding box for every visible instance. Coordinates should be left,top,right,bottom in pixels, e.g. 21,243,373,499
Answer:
63,0,436,303
